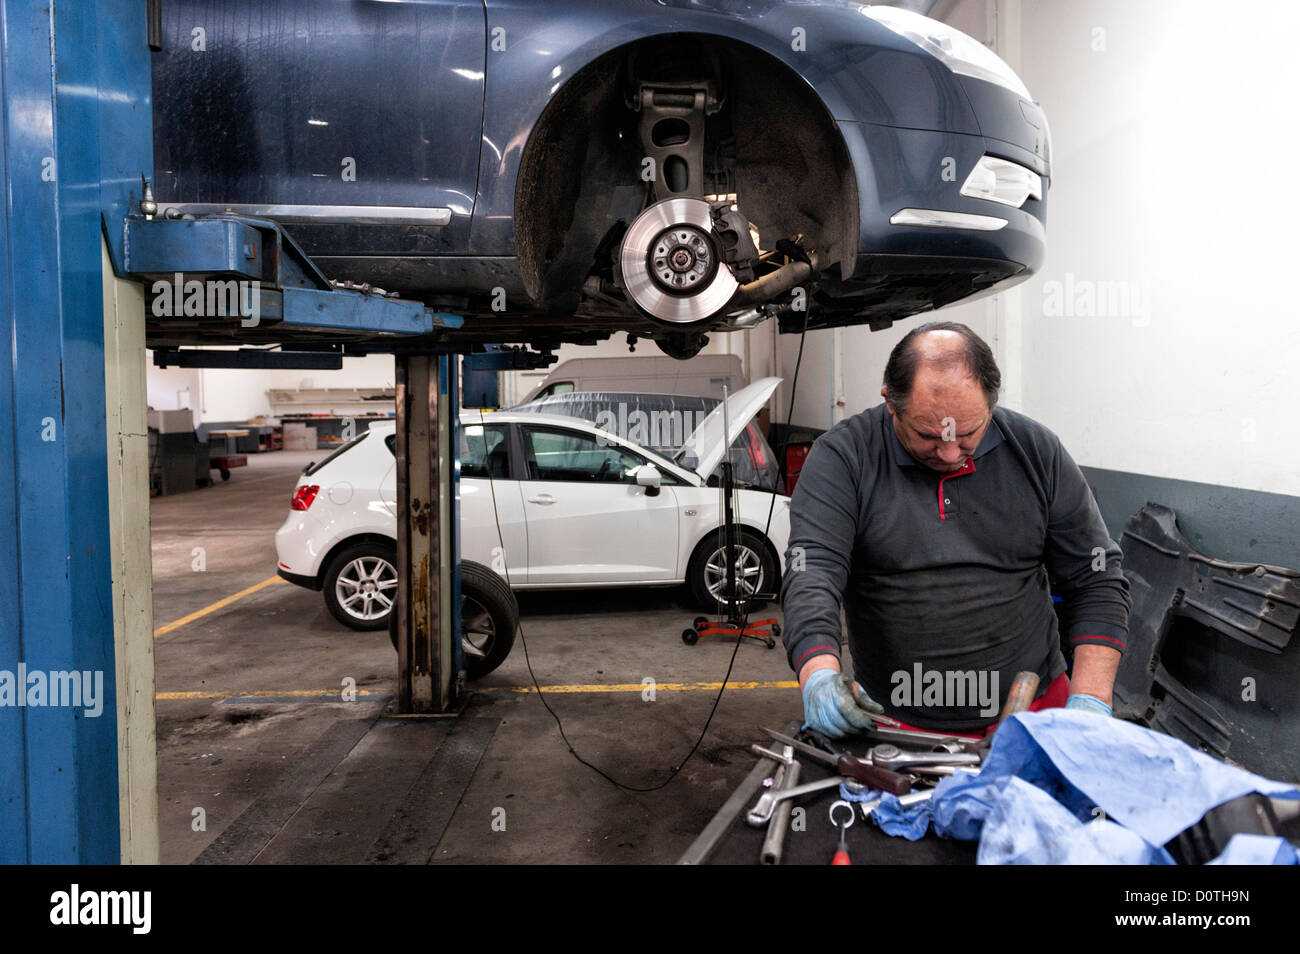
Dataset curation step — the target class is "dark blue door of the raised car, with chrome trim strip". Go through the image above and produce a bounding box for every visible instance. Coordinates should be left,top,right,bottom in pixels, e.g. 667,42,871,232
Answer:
152,0,486,255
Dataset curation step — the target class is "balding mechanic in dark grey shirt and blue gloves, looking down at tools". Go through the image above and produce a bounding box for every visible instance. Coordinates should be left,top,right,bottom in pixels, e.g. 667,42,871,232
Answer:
781,322,1130,738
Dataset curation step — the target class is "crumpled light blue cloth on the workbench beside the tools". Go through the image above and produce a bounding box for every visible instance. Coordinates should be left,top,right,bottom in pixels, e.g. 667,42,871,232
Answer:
857,708,1300,864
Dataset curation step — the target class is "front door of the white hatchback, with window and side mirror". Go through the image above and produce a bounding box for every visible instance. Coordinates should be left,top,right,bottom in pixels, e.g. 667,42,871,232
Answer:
519,424,677,586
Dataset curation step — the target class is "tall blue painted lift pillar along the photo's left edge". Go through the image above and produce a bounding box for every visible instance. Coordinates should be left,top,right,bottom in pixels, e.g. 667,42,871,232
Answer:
0,0,152,864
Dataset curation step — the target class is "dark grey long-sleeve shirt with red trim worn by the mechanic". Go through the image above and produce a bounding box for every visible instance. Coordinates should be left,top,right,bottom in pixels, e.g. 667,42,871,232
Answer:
781,404,1130,730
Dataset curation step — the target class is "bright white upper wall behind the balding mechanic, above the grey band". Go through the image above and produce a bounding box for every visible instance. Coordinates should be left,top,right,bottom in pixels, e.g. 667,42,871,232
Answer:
781,0,1300,494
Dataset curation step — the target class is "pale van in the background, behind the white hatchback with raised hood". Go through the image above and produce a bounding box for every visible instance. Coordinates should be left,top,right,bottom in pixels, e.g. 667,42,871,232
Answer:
519,355,749,404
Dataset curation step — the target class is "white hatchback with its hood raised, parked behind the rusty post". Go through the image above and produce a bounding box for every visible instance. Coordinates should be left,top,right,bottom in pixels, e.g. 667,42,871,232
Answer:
276,378,790,629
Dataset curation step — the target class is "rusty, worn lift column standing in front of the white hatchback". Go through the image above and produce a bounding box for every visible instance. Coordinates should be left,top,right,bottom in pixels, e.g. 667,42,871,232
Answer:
394,354,460,714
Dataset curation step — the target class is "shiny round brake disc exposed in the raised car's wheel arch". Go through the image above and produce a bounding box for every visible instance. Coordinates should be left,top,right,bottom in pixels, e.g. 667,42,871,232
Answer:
619,198,738,325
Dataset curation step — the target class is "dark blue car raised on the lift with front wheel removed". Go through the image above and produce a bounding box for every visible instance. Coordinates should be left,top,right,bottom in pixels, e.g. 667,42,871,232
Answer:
150,0,1050,356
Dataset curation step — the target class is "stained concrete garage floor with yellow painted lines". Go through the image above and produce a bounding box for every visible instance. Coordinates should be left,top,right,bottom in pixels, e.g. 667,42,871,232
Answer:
152,451,801,864
